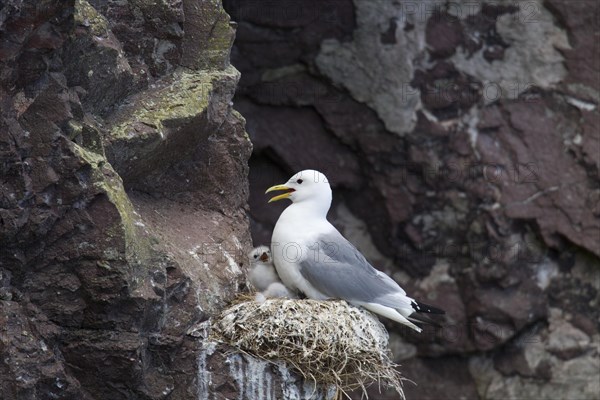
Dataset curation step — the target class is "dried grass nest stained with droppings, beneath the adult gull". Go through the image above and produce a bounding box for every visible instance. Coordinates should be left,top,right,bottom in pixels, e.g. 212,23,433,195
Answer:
212,298,404,398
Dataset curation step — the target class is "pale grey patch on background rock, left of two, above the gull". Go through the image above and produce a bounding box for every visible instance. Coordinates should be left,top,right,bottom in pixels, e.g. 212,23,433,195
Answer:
315,0,425,134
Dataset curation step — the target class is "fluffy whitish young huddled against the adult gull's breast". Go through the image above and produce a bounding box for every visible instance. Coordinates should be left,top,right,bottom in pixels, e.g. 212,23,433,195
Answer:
248,246,296,303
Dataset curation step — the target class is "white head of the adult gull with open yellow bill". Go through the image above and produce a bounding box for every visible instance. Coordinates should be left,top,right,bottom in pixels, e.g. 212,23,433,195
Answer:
265,169,331,214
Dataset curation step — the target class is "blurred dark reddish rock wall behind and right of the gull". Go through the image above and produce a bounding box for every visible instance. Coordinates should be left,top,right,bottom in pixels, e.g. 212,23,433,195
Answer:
224,0,600,399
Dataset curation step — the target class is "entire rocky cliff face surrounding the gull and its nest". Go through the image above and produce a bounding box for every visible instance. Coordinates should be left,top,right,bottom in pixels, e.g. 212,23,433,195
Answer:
0,0,600,400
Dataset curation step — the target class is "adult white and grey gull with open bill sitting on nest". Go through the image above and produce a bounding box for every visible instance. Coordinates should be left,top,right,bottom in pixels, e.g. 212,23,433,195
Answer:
265,170,444,332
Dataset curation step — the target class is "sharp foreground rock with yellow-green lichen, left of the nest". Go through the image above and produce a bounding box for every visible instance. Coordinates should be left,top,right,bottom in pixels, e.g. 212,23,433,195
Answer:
0,0,316,400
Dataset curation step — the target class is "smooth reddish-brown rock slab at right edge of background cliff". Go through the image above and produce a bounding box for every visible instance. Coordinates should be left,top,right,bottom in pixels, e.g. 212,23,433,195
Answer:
478,100,600,254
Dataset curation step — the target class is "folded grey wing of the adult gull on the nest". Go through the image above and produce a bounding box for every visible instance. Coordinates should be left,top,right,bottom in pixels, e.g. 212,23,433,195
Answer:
300,231,408,307
